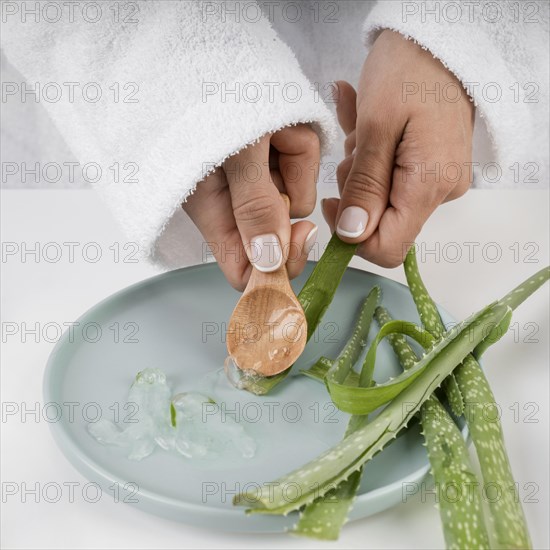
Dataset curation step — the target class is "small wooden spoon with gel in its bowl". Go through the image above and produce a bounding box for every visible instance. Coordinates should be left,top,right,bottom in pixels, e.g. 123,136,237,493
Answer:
226,195,307,376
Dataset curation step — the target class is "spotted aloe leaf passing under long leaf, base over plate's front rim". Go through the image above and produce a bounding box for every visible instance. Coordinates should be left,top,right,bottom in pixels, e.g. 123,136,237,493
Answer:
292,287,381,540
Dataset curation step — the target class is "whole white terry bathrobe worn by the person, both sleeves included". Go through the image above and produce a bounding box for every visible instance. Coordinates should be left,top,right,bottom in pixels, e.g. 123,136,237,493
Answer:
2,0,549,267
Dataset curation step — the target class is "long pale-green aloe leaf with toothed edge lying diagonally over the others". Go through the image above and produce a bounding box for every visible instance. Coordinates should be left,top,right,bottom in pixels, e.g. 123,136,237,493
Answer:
233,304,507,514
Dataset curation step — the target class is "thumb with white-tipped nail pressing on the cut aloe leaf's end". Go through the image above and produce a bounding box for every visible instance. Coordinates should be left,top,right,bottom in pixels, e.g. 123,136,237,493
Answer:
336,125,401,243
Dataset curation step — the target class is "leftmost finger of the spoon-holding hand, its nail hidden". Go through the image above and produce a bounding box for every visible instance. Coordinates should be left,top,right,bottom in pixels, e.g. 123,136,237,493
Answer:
182,168,251,290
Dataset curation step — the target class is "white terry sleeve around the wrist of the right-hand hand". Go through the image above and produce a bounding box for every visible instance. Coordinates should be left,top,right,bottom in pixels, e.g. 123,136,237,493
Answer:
364,0,550,188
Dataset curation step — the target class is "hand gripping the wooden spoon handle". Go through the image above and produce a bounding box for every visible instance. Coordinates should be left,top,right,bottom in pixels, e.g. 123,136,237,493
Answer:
182,125,320,290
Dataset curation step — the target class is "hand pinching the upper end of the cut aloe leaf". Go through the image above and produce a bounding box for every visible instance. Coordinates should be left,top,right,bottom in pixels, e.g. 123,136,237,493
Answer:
323,31,474,267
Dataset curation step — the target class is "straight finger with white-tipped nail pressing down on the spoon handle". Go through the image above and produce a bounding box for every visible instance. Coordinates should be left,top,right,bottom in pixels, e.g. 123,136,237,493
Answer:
224,136,290,273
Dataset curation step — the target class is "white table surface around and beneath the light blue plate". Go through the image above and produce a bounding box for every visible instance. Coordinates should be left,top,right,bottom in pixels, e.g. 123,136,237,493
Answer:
1,190,550,549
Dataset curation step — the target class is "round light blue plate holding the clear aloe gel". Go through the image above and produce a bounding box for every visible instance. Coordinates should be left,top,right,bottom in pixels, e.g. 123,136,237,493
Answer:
44,263,462,532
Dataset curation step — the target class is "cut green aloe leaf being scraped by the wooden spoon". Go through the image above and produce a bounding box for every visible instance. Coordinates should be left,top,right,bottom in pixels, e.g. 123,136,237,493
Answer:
242,233,358,395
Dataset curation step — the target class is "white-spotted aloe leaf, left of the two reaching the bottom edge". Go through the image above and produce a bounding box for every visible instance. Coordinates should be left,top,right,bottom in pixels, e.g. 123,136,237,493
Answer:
375,307,492,549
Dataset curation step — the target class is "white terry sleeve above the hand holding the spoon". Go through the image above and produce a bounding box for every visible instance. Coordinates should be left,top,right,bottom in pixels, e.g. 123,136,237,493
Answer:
2,0,335,267
